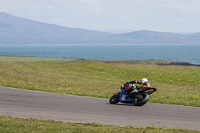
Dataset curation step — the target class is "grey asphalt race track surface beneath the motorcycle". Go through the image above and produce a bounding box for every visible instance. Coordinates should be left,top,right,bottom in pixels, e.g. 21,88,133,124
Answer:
0,87,200,130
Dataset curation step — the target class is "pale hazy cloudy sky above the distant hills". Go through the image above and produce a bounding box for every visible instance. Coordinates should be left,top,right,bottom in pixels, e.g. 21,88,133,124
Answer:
0,0,200,33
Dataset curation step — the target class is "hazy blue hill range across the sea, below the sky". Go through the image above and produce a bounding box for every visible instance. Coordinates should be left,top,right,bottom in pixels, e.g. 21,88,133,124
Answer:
0,13,200,45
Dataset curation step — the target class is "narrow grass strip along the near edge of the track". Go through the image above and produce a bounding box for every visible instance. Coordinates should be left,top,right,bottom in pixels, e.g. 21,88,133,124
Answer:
0,116,199,133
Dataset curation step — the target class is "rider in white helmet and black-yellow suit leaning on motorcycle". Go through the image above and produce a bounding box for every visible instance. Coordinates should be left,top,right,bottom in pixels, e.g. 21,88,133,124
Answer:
126,78,150,92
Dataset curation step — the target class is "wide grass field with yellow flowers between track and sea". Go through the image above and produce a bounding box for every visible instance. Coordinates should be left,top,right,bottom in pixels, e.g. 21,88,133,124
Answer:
0,56,200,107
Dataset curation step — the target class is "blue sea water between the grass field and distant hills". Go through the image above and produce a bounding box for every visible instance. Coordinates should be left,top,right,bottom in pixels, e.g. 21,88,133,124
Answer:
0,45,200,64
